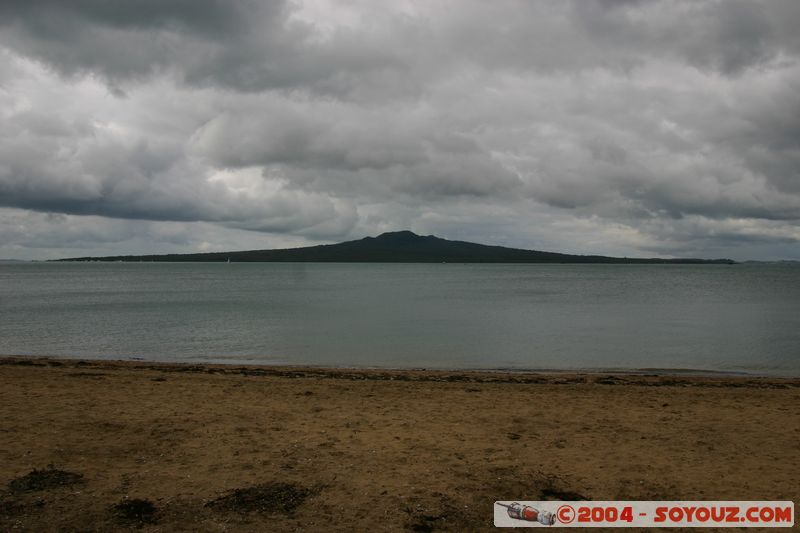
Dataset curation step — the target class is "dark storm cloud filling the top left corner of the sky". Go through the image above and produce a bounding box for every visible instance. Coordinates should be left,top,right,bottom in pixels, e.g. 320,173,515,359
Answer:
0,0,404,91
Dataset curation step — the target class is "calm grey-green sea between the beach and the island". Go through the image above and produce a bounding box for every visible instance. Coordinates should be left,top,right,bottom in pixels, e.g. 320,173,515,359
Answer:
0,263,800,376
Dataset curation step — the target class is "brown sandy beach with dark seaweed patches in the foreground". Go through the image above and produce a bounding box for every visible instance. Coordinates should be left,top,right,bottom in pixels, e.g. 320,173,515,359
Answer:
0,358,800,532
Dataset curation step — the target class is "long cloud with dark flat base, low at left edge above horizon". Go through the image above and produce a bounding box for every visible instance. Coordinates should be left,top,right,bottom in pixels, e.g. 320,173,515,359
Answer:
0,104,352,235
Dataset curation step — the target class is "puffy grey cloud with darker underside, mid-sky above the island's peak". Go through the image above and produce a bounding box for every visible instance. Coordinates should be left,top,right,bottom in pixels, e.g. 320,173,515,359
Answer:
192,94,521,199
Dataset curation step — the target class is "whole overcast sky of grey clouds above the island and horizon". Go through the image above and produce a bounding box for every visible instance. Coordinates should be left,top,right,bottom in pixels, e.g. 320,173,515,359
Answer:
0,0,800,260
